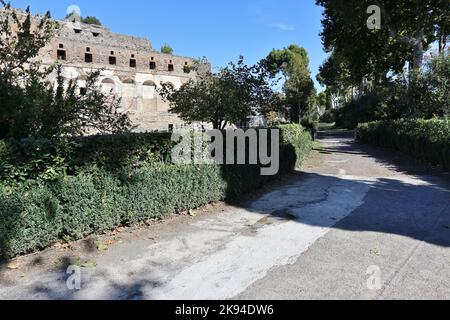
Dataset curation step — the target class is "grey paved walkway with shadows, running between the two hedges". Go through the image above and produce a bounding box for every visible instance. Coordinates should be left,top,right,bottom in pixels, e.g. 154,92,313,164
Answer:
0,132,450,299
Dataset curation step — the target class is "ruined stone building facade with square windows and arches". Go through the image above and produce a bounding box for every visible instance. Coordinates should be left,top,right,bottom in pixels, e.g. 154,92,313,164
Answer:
39,21,211,131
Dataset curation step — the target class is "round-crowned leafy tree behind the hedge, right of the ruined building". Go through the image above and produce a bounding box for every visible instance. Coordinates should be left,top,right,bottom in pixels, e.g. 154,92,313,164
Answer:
160,57,274,130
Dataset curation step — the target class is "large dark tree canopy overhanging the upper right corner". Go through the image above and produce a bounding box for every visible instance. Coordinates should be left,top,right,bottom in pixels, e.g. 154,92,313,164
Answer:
316,0,449,84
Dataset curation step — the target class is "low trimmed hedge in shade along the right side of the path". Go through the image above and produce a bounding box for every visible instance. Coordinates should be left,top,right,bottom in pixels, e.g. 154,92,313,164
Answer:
356,119,450,170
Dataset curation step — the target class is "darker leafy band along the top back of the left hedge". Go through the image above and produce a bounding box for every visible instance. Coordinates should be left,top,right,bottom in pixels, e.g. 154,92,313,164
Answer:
0,133,173,186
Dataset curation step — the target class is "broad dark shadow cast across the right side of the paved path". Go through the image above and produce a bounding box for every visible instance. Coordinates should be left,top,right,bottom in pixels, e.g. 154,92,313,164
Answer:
217,130,450,247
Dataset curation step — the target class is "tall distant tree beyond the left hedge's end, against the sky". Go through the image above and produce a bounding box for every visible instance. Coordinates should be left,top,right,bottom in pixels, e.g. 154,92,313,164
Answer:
266,45,315,122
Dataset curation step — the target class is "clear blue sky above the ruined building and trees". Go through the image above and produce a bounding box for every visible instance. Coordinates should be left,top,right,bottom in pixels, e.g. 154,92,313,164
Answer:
11,0,326,89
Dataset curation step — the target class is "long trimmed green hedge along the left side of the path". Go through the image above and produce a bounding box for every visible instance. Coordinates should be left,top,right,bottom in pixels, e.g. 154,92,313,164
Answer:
0,125,312,258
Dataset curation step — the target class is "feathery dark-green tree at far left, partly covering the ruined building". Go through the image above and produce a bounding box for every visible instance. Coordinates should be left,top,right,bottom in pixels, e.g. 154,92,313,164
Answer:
0,0,131,139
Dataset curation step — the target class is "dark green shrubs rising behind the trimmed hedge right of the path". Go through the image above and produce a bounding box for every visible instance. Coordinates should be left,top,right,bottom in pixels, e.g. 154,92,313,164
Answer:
335,55,450,129
